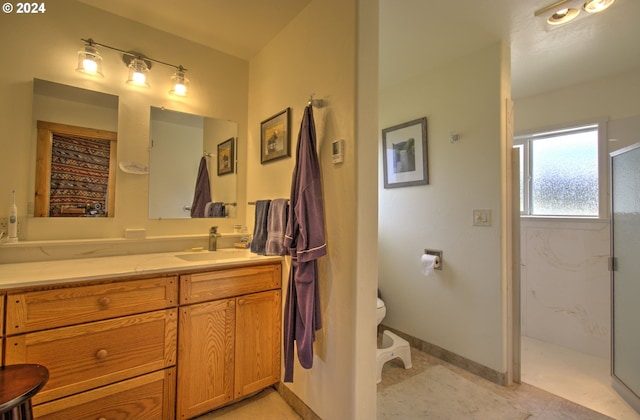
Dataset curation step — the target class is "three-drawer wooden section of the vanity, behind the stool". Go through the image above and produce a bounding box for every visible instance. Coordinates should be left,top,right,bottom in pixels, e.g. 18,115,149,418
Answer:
4,275,178,420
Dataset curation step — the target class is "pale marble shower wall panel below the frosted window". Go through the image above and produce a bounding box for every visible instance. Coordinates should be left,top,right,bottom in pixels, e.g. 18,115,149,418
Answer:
521,219,611,358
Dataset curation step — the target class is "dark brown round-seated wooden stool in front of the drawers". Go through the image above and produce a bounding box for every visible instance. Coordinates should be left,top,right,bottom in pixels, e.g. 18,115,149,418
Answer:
0,364,49,420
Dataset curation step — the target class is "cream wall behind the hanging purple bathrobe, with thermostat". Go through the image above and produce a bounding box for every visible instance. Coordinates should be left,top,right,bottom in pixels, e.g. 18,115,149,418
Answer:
247,0,377,419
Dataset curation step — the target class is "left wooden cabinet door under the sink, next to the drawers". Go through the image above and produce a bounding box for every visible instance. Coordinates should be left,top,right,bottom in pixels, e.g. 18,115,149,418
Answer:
176,299,236,419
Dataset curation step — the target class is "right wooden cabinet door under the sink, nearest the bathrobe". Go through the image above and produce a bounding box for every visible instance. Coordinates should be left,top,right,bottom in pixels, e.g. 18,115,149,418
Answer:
234,290,281,398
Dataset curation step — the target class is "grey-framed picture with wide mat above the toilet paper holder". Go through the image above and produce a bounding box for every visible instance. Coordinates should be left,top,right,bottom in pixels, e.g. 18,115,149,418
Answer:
382,117,429,188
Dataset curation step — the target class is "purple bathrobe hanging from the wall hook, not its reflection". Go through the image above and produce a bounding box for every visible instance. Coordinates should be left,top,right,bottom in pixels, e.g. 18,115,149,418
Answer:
284,105,327,382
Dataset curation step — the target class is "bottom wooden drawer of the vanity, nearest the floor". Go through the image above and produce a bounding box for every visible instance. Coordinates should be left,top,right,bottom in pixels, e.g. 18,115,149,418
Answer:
33,368,175,420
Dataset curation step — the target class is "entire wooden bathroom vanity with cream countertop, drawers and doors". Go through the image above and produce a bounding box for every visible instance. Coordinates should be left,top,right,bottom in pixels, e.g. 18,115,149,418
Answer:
0,252,282,419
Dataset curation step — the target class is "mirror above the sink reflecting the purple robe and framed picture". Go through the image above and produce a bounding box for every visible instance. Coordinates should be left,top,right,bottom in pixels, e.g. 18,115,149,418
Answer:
149,107,238,219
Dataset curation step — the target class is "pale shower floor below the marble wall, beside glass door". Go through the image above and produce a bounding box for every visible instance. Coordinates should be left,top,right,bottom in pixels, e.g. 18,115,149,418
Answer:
521,337,640,420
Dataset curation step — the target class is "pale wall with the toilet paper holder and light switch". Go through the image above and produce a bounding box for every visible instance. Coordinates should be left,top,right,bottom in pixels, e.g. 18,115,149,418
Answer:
379,44,510,373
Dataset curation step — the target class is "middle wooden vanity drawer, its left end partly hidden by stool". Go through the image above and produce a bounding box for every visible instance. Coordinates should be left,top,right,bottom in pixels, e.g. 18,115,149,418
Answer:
5,309,177,404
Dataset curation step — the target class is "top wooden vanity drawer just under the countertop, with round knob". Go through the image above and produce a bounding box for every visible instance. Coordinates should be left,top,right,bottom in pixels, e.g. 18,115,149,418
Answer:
7,276,177,335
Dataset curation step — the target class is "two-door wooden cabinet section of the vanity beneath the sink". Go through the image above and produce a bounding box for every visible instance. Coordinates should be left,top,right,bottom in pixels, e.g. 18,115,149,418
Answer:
176,262,282,419
